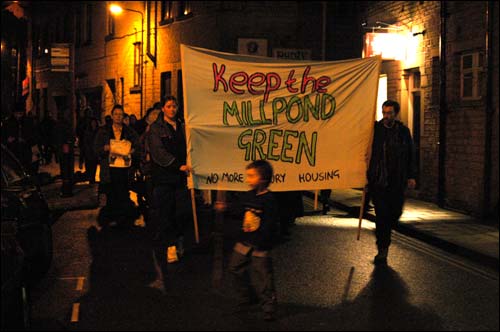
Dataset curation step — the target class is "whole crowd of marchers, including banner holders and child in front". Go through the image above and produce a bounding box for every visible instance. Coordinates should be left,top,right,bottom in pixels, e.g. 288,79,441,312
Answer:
2,96,416,320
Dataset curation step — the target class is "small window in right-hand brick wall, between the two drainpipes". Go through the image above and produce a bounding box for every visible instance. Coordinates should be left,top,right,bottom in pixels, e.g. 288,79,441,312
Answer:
460,52,483,100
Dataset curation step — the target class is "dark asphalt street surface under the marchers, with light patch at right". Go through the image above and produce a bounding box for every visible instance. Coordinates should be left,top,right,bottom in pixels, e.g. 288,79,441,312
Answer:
32,198,499,331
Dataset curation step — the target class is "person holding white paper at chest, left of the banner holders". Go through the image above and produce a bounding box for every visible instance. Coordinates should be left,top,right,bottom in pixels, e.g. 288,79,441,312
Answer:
94,105,139,227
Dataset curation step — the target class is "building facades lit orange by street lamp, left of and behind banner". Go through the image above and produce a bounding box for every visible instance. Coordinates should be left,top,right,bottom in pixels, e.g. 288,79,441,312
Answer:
28,1,362,119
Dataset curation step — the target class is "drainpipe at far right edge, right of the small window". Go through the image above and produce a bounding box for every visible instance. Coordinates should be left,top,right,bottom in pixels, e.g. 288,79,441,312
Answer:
482,1,494,218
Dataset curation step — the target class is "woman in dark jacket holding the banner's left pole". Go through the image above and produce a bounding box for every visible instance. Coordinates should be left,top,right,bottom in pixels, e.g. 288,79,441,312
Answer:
146,96,191,267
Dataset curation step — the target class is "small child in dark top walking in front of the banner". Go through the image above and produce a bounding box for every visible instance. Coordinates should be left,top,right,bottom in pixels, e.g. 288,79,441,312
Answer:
215,160,278,320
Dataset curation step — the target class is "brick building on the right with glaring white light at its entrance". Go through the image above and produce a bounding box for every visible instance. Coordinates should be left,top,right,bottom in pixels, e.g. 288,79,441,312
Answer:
364,1,499,218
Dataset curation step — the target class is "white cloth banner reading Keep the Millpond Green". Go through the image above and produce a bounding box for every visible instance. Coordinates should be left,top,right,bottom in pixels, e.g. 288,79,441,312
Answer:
181,45,380,191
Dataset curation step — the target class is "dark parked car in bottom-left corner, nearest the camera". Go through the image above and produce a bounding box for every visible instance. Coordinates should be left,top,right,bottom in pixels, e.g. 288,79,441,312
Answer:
1,221,31,331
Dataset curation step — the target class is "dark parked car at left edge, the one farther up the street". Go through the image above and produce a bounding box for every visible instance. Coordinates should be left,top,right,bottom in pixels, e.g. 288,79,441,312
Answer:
1,145,52,280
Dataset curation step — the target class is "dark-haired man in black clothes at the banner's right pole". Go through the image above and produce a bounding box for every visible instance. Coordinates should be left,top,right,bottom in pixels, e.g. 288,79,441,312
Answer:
367,100,416,264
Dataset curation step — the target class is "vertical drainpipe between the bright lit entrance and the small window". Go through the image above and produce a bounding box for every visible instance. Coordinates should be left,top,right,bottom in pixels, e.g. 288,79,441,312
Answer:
438,1,448,207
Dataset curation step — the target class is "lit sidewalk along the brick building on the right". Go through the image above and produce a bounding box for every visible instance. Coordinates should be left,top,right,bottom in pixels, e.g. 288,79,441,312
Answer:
314,189,499,269
